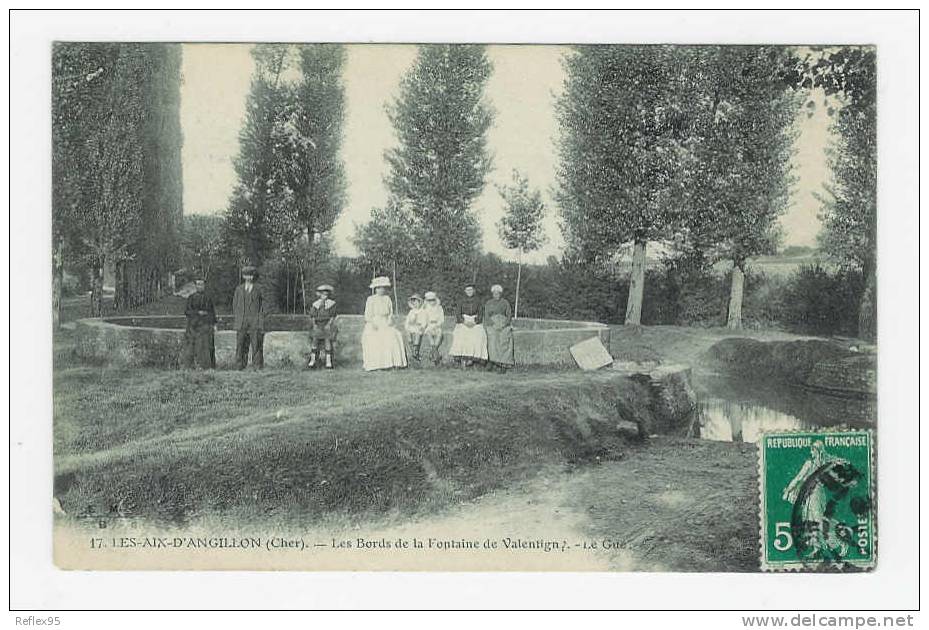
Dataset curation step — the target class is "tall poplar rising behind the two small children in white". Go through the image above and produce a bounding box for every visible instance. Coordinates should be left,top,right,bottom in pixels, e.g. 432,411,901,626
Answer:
386,44,493,282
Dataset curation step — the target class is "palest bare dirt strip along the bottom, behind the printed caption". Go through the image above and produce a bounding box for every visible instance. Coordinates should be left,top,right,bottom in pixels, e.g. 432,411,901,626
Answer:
57,466,632,571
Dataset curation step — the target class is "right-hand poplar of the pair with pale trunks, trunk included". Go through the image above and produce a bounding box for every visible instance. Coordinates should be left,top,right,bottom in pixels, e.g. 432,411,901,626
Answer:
683,46,799,328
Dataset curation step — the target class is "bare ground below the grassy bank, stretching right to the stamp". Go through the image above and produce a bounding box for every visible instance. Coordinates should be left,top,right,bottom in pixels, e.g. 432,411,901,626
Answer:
61,437,758,572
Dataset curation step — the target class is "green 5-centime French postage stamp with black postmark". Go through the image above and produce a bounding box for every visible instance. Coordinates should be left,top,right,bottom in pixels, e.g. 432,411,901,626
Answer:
758,431,875,571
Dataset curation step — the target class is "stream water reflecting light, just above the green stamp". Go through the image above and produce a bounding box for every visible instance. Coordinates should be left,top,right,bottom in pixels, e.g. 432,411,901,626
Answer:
691,374,877,442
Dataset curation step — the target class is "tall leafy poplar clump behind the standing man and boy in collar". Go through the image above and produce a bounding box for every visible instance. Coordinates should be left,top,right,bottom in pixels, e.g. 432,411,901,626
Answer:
226,44,346,293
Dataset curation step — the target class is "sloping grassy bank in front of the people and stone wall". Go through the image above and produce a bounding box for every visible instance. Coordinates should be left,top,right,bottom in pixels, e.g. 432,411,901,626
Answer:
55,334,648,522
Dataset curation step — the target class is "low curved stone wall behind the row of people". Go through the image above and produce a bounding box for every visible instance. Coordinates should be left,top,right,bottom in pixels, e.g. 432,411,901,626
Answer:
75,315,610,368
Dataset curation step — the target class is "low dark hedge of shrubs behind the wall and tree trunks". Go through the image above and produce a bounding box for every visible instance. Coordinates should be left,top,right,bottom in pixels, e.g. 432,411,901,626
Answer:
188,248,864,335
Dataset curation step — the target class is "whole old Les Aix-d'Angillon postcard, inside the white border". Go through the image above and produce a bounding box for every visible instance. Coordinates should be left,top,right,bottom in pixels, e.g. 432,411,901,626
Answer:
48,40,876,572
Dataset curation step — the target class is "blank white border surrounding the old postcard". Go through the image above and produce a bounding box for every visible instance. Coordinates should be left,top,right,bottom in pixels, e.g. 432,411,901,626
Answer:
7,6,919,616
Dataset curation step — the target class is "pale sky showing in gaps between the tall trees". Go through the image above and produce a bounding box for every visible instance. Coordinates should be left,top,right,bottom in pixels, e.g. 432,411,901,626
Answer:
181,44,829,262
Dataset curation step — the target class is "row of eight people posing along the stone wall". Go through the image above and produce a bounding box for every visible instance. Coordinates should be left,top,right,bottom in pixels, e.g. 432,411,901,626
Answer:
182,267,515,372
